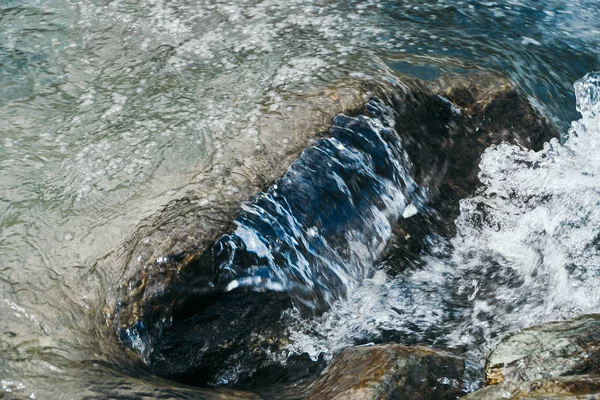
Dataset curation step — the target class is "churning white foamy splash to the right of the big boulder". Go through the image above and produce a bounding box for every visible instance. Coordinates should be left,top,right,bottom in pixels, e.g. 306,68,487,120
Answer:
290,73,600,389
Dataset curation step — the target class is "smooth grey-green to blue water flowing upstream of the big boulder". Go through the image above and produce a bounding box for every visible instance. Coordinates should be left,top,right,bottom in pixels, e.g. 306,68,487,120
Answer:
0,0,600,398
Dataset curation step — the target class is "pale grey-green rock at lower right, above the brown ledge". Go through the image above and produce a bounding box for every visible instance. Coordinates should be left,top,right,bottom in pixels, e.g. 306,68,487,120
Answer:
485,314,600,384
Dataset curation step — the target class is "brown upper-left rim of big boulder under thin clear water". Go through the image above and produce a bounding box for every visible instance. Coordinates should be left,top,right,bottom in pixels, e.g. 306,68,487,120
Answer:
101,82,370,359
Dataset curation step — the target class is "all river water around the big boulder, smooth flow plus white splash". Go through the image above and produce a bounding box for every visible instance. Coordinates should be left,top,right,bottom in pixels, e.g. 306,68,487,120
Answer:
0,0,600,399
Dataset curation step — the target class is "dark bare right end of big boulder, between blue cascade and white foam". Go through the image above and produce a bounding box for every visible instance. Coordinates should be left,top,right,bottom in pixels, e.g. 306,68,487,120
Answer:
387,75,559,274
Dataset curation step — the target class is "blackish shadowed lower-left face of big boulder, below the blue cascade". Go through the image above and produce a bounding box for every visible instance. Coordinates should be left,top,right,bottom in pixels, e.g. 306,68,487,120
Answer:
150,290,302,389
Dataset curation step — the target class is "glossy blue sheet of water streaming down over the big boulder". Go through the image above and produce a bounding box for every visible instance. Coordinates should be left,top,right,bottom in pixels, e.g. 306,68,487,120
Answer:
215,99,426,310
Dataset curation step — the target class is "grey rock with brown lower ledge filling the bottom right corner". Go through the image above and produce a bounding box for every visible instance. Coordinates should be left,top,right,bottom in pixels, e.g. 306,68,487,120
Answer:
466,314,600,400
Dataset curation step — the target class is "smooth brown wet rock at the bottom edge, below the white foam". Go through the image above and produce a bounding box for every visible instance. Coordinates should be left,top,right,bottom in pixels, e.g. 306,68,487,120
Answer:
306,344,464,400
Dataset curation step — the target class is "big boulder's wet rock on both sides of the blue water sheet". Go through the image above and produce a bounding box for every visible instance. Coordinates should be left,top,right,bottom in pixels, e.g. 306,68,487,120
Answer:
110,77,557,390
